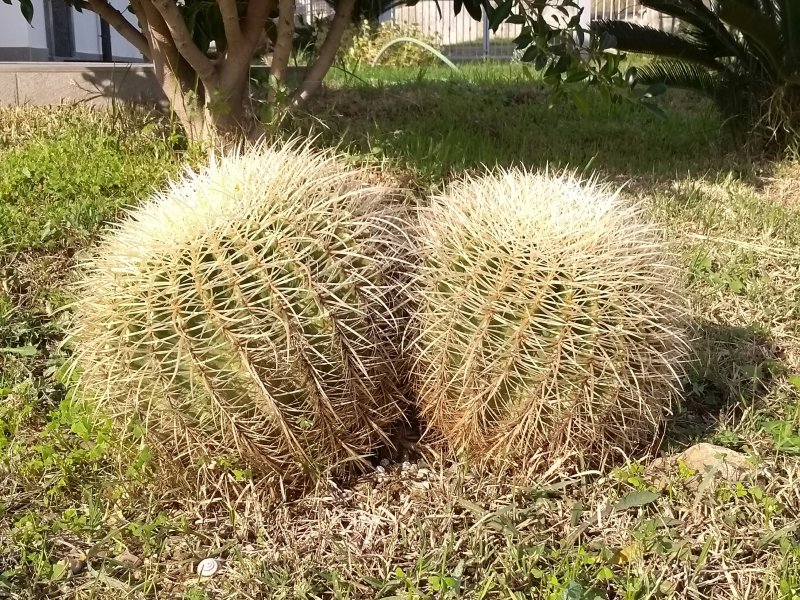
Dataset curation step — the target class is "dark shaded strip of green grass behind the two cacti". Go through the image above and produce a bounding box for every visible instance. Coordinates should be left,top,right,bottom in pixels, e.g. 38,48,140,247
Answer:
301,78,735,183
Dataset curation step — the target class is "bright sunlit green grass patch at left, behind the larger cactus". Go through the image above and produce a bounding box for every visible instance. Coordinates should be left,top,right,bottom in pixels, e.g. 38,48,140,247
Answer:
0,108,185,250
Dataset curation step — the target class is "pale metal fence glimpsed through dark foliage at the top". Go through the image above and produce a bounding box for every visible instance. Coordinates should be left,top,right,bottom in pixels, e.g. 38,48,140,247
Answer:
297,0,675,61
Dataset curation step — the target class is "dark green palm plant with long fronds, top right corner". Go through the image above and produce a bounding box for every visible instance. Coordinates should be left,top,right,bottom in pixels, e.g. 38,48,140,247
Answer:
592,0,800,145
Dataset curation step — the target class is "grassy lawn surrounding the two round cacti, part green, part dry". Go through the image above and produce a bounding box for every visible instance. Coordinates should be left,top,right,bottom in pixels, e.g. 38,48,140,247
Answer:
0,64,800,600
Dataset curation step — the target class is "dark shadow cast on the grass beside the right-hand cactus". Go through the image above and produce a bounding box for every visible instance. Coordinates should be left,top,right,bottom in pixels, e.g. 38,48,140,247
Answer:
666,321,781,446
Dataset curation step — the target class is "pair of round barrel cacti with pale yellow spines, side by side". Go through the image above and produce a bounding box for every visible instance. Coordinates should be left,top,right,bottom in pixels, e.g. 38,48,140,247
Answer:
70,142,687,494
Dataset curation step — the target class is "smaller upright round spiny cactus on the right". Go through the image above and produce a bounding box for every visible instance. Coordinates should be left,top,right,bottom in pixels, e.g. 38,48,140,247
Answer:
409,171,688,465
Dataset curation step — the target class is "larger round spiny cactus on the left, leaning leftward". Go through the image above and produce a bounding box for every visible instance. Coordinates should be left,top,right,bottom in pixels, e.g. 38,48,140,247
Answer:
71,142,400,492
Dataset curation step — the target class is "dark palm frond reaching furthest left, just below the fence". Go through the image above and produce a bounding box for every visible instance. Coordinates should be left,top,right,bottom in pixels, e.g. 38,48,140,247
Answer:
592,20,723,70
